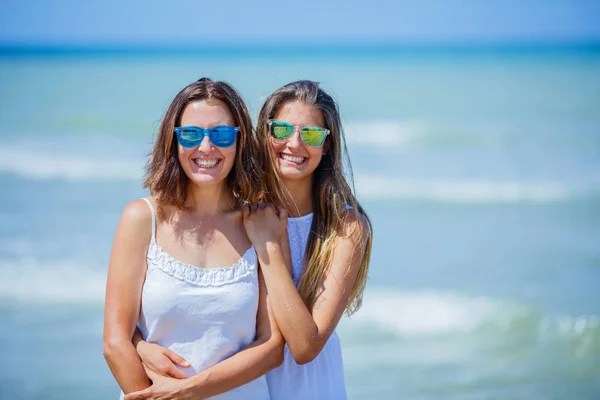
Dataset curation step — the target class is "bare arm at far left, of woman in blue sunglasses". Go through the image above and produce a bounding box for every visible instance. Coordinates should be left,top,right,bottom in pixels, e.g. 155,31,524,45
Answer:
104,200,152,393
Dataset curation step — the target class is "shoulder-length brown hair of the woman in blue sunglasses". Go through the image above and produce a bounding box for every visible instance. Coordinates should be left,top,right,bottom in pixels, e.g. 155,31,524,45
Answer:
143,78,260,209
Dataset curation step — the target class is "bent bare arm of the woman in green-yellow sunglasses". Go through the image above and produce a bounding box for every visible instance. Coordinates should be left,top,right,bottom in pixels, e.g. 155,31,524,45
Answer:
249,209,368,364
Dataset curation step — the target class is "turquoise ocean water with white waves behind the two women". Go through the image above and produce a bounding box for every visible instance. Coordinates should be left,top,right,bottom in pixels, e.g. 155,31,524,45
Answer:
0,47,600,400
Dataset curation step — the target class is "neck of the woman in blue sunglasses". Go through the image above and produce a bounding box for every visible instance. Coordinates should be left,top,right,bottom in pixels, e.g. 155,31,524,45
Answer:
185,182,234,216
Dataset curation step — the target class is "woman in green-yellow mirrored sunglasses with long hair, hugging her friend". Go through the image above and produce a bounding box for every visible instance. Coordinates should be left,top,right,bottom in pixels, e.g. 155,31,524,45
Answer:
134,81,372,400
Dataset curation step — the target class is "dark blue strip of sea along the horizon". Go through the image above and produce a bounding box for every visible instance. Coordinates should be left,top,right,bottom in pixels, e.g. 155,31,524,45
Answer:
0,38,600,57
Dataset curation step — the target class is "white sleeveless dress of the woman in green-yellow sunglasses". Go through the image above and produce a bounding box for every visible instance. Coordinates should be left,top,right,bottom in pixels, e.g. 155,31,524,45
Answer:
267,214,347,400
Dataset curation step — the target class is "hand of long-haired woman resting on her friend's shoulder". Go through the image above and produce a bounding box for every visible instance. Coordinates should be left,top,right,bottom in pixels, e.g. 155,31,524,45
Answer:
242,203,288,247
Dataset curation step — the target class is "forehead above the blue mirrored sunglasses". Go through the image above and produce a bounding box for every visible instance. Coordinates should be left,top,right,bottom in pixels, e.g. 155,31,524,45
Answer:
181,100,235,128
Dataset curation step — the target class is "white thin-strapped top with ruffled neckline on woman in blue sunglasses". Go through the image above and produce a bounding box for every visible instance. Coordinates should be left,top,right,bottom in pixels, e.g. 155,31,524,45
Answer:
122,198,270,400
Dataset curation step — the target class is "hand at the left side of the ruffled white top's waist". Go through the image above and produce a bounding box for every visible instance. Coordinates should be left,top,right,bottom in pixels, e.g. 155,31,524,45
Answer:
136,340,191,379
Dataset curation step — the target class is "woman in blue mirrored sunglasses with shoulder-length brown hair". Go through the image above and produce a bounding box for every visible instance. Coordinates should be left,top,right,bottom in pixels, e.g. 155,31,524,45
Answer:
104,78,283,400
